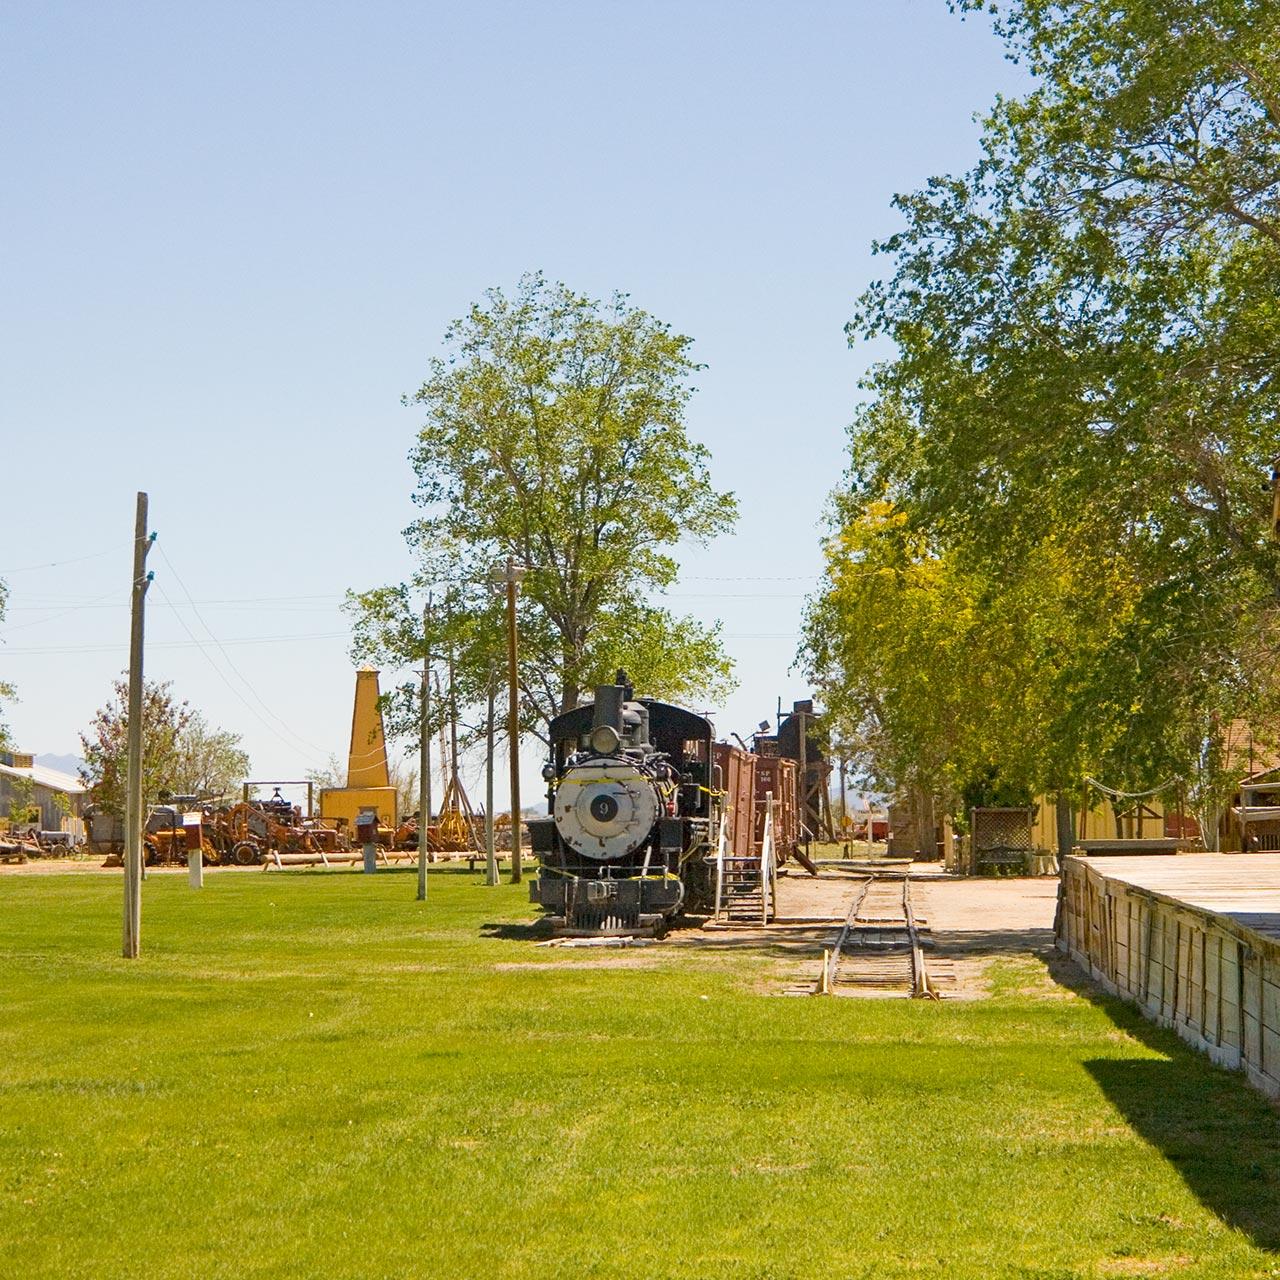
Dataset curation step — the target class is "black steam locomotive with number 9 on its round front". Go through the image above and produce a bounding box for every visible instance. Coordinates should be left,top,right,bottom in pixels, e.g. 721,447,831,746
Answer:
529,671,721,934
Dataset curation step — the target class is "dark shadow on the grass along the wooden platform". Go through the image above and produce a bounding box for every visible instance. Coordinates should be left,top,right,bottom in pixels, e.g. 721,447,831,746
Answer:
1050,957,1280,1252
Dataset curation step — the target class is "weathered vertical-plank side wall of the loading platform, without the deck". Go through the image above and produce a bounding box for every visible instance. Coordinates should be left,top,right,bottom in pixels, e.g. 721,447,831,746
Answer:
1056,856,1280,1098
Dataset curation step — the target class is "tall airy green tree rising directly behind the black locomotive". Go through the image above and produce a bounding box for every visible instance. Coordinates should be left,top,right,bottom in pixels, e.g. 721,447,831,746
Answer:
352,275,736,747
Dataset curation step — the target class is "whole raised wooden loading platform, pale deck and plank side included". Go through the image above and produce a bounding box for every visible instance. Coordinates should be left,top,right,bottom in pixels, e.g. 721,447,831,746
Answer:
1055,854,1280,1098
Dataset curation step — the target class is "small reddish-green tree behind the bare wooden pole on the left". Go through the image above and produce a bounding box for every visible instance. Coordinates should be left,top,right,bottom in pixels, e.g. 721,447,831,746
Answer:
81,680,248,814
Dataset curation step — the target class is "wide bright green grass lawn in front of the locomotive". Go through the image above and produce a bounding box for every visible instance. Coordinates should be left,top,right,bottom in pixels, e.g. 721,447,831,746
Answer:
0,870,1280,1280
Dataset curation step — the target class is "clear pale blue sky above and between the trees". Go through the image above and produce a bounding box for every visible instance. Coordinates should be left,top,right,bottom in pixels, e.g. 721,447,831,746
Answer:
0,0,1023,794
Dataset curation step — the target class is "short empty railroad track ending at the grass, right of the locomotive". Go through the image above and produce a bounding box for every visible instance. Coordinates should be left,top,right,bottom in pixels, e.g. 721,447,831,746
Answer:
814,870,951,1000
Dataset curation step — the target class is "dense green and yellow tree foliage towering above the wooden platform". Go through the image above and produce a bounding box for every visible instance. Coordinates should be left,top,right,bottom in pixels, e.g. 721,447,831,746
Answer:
808,0,1280,819
